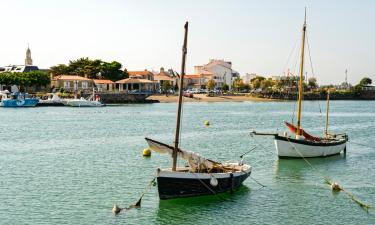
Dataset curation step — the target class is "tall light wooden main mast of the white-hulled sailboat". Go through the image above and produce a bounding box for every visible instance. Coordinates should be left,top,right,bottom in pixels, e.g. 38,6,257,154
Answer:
296,8,306,137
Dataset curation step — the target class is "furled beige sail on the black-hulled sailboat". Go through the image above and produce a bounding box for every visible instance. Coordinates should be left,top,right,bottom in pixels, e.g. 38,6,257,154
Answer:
146,138,220,172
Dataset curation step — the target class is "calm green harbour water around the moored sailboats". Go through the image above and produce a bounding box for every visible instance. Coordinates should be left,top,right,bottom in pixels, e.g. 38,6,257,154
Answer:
0,101,375,224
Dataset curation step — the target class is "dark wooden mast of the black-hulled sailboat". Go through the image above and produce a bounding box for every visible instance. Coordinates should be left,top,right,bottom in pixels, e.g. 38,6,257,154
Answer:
172,22,189,171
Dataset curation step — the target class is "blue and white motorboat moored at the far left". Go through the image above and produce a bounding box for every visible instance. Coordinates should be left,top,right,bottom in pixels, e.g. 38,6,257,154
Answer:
0,91,39,108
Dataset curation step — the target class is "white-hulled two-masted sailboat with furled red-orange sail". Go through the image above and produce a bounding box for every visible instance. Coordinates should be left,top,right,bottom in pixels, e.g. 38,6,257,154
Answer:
253,11,348,158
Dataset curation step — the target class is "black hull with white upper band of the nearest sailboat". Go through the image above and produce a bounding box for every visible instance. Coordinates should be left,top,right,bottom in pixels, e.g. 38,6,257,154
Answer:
157,166,251,200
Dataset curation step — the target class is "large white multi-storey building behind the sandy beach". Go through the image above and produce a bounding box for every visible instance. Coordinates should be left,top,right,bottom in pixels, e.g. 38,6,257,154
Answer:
194,59,239,89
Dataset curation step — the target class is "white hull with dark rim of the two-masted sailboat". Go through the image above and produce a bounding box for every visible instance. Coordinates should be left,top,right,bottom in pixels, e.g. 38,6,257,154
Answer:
275,135,347,158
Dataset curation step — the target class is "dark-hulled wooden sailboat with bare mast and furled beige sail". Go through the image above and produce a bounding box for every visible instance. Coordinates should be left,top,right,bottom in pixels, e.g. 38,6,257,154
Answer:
146,22,251,199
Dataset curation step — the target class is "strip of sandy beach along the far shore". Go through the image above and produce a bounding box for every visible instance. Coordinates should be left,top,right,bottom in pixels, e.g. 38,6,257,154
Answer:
147,94,275,103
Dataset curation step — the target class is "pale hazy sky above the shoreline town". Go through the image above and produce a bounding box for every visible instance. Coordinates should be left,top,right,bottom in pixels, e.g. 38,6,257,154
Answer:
0,0,375,84
